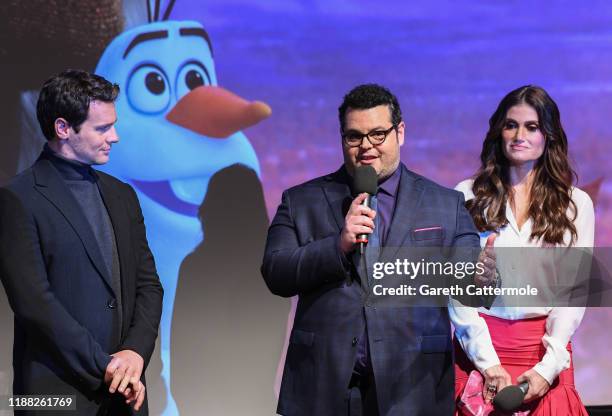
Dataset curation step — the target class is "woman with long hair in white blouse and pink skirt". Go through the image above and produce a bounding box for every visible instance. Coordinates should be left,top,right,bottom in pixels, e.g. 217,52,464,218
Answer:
450,86,594,416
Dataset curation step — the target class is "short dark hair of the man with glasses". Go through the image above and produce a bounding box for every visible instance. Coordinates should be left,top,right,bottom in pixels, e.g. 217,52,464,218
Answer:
338,84,402,131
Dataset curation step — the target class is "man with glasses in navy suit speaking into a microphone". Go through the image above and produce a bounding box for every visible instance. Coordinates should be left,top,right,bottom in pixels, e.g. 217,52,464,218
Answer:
262,84,491,416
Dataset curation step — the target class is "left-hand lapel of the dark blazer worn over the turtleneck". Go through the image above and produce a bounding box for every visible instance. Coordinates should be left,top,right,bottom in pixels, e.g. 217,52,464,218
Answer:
33,159,113,290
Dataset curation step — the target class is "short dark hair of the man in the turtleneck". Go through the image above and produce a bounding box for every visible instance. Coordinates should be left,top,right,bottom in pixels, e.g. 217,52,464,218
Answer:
36,69,119,140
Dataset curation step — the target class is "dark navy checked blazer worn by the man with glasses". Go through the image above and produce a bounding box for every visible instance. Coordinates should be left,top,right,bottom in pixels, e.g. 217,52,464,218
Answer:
262,164,479,416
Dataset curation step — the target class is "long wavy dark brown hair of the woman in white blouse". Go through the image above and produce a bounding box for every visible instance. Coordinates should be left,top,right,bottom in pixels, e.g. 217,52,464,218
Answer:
466,85,577,245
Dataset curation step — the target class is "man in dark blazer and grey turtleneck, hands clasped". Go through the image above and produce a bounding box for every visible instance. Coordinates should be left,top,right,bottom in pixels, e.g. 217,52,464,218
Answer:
0,70,163,415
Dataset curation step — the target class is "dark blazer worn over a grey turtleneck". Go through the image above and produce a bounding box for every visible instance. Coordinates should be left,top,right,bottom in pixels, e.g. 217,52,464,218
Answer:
0,156,163,415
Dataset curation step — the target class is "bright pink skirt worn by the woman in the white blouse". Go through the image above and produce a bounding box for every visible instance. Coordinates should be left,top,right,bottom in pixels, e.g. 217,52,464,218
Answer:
454,314,588,416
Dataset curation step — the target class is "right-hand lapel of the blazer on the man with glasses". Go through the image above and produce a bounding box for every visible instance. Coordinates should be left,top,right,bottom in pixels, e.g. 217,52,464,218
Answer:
382,164,424,259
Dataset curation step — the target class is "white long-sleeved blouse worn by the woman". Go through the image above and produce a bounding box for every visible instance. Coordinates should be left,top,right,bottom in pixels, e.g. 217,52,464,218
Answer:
449,179,595,384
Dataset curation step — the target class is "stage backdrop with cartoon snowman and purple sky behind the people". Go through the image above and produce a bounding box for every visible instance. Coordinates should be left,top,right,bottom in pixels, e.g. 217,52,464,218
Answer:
0,0,612,415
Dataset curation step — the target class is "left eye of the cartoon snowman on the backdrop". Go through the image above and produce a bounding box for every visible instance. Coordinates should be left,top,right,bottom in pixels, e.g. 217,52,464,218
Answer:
127,64,170,114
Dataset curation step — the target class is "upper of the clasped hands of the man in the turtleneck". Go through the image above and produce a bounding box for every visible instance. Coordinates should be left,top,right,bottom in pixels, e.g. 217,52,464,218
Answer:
104,350,144,397
